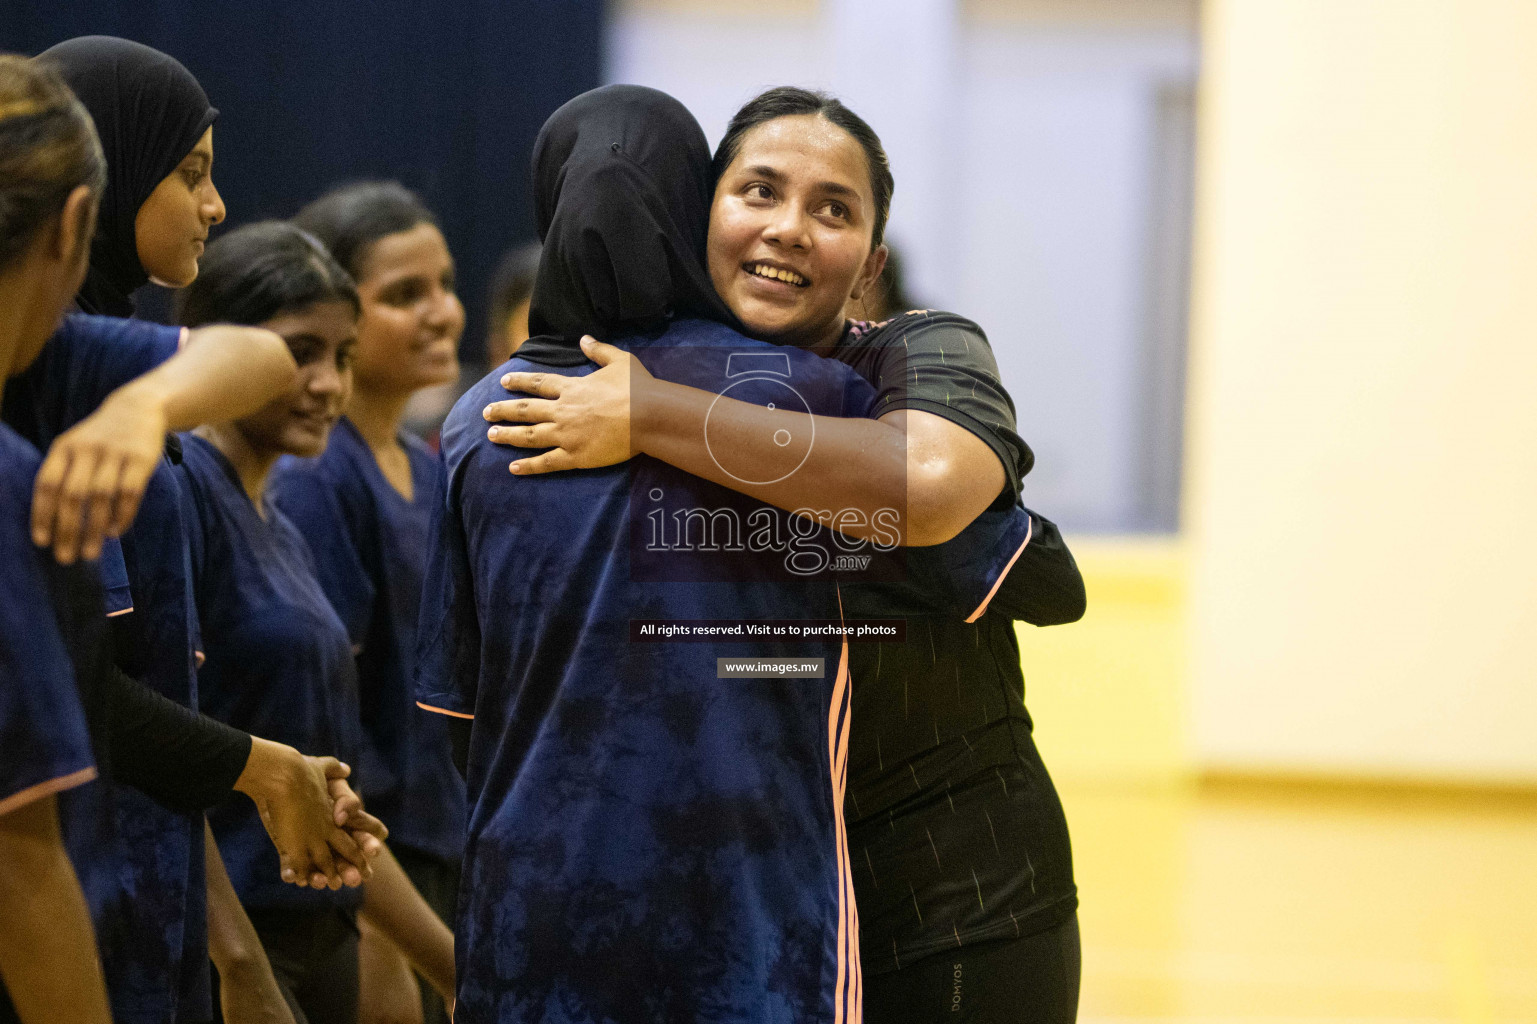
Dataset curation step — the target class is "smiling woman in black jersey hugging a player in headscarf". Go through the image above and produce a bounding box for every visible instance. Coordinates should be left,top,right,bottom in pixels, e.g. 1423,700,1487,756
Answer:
486,89,1084,1024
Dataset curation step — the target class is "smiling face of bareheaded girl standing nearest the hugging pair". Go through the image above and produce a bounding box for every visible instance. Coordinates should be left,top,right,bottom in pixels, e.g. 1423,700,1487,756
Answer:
355,223,464,395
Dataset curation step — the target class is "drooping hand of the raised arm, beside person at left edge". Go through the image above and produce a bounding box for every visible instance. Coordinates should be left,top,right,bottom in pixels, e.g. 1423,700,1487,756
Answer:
32,376,168,566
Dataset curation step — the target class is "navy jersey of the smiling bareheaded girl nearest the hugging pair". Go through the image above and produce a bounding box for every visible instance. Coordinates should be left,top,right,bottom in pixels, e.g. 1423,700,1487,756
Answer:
267,418,464,864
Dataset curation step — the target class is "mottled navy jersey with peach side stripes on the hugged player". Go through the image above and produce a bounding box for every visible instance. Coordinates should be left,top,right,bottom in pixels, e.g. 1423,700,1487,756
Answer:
417,321,871,1024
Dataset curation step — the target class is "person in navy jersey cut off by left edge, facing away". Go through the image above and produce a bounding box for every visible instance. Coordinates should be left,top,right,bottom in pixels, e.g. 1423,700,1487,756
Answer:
0,55,111,1024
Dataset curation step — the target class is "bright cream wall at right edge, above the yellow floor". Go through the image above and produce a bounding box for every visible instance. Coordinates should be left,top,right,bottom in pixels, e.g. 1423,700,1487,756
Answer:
1187,0,1537,783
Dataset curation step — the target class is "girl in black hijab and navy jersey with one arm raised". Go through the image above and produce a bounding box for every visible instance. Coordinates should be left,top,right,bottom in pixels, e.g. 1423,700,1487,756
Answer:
5,37,387,1024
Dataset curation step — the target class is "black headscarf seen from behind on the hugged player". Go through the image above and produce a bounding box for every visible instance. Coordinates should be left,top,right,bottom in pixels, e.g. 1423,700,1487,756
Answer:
518,85,741,366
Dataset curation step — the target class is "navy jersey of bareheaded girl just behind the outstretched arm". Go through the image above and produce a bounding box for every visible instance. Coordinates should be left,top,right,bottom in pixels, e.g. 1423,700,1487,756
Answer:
180,434,366,909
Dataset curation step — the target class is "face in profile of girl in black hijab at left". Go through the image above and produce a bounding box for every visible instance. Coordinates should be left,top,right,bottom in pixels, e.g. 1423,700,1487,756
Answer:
134,128,224,288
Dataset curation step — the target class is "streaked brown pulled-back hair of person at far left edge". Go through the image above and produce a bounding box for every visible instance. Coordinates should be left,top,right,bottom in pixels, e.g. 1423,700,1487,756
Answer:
0,54,106,266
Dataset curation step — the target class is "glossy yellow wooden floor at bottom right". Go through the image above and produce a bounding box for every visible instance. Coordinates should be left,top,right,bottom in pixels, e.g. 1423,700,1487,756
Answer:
1059,780,1537,1024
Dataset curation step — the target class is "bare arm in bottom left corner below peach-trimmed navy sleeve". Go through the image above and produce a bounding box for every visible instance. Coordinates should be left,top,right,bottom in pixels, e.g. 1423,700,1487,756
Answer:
0,796,112,1024
